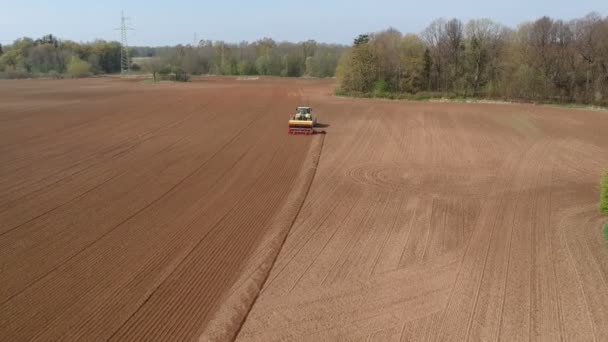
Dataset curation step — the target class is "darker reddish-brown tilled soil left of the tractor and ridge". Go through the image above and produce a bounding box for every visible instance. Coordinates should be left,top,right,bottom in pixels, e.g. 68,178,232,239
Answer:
0,79,312,341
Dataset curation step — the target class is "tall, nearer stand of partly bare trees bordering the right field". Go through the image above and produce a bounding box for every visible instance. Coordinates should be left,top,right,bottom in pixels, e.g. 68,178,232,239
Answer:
337,13,608,105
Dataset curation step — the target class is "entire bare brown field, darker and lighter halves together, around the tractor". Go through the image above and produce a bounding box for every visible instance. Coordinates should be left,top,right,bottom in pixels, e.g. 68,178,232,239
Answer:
0,79,608,341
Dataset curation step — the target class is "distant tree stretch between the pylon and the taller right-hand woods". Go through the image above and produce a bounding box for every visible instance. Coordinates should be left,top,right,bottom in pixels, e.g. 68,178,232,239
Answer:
135,38,346,77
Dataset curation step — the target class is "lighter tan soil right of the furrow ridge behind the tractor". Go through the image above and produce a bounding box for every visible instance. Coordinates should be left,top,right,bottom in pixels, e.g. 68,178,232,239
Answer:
234,80,608,341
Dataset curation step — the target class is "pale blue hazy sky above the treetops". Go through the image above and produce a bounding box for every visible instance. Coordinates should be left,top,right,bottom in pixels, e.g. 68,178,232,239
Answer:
0,0,608,45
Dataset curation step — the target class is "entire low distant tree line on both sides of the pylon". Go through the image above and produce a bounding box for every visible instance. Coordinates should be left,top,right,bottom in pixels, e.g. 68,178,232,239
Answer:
0,35,347,78
